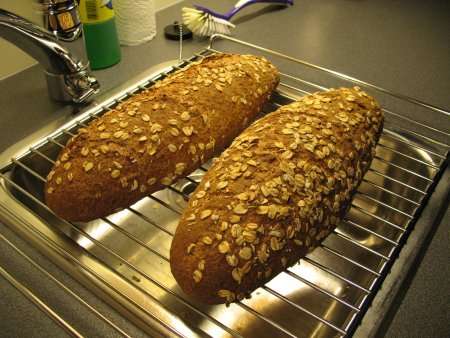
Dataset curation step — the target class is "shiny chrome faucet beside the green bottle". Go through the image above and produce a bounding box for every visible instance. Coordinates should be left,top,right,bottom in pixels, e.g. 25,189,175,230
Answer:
0,0,100,103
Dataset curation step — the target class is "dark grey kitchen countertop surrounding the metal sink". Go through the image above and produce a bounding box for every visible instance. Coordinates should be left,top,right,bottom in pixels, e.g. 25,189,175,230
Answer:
0,0,450,337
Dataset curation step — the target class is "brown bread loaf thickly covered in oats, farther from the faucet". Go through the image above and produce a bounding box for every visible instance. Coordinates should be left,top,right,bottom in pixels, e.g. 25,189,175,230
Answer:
170,88,383,304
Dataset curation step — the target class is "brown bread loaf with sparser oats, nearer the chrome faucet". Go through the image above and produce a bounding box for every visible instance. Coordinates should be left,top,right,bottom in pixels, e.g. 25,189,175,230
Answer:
45,54,279,221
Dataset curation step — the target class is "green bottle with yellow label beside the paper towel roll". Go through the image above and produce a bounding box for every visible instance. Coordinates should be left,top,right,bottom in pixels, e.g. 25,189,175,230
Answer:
79,0,121,69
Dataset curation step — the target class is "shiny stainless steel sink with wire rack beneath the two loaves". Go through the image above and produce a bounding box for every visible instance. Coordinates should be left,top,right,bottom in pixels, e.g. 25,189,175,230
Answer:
0,37,449,337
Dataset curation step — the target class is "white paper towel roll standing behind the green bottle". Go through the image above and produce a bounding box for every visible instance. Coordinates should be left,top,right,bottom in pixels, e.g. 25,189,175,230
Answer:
114,0,156,46
